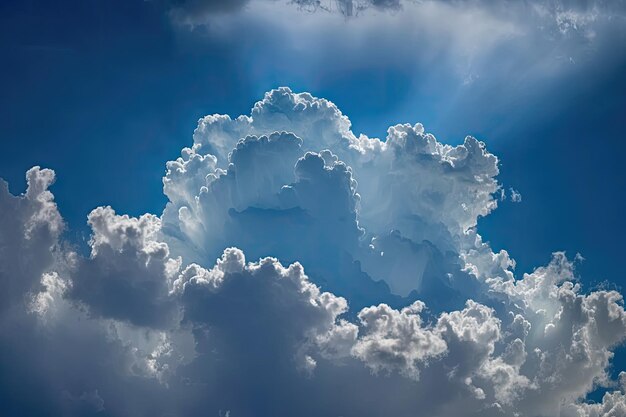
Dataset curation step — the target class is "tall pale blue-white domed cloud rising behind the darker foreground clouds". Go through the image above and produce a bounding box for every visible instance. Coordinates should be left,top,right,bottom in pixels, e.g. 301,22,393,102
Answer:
163,88,499,302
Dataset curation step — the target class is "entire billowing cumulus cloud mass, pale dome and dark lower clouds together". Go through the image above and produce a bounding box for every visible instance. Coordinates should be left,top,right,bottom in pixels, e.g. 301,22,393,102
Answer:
0,88,626,417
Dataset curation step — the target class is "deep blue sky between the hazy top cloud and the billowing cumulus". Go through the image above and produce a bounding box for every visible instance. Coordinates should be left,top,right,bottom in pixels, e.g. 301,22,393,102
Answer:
0,0,626,285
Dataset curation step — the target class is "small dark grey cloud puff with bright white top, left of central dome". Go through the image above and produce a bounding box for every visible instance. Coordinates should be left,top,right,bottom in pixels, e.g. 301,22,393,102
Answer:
68,207,180,327
